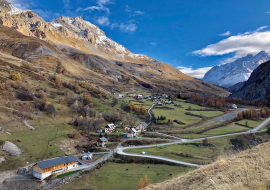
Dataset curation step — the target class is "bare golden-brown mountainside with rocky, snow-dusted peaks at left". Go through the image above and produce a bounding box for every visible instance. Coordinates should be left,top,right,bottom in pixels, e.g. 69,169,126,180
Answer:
0,0,227,94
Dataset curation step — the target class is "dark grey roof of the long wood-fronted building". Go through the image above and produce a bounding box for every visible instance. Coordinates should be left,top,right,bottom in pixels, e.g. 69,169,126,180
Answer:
37,156,77,169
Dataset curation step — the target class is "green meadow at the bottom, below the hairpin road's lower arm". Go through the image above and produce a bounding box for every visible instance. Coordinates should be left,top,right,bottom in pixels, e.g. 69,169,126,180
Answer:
58,163,194,190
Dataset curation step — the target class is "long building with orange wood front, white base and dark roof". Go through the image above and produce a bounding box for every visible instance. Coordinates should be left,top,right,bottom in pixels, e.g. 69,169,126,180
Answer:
33,156,78,180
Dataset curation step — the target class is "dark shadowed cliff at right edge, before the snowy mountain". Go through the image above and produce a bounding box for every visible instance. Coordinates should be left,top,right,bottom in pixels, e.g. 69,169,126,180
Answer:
231,61,270,100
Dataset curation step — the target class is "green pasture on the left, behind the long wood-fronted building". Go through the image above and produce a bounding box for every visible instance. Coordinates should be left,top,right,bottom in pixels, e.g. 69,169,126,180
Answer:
0,112,72,170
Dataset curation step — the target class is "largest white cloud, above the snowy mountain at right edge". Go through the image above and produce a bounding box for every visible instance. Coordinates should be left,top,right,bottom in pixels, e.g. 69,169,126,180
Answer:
192,26,270,63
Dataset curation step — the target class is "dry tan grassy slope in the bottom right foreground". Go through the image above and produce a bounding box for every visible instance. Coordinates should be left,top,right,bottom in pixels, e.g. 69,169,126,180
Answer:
145,142,270,190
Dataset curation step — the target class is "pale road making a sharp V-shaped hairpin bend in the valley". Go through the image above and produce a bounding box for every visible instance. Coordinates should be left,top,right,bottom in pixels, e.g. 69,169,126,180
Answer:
116,118,270,167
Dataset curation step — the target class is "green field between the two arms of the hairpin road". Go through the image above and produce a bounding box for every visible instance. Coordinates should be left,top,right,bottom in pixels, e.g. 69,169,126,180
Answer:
125,137,233,164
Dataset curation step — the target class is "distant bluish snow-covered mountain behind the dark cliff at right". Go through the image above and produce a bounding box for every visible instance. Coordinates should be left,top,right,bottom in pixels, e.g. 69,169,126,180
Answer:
202,51,270,87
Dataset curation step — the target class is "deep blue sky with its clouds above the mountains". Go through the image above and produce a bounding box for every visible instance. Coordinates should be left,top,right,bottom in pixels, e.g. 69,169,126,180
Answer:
8,0,270,78
